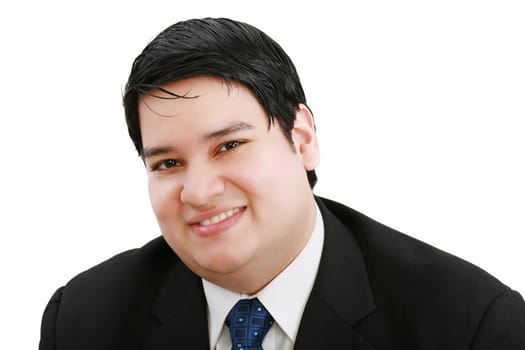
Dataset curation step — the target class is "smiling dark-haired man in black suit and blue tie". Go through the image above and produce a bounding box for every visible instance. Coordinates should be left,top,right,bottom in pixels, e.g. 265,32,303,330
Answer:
40,18,525,350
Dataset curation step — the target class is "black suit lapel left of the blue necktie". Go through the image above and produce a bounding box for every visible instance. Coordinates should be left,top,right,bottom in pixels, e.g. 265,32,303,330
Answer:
145,261,210,350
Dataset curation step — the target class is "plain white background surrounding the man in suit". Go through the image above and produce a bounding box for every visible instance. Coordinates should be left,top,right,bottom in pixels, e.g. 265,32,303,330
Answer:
0,0,525,349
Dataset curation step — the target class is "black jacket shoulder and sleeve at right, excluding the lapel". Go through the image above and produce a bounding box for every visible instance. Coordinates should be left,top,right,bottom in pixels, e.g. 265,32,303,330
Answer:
320,199,525,349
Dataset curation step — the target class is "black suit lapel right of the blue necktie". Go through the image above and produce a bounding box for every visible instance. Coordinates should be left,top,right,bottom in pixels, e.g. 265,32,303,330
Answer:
295,200,375,350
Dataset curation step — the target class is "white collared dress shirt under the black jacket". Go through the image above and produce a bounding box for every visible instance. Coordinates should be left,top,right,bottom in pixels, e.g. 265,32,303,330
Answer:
202,204,324,350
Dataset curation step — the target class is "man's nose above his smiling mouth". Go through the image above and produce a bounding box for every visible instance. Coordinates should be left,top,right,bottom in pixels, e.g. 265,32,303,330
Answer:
180,163,224,207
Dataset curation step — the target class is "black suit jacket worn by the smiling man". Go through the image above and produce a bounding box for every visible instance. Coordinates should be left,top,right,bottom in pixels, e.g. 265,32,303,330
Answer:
40,198,525,350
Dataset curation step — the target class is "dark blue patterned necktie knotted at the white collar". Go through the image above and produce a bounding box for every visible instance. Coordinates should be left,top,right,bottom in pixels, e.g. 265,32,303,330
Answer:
226,298,273,350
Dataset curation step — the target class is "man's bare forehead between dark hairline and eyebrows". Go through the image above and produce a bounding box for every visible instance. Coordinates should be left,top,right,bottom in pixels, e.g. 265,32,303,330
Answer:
139,77,268,149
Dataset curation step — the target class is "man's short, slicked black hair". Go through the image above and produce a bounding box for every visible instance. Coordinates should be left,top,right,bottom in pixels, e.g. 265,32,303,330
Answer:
123,18,317,188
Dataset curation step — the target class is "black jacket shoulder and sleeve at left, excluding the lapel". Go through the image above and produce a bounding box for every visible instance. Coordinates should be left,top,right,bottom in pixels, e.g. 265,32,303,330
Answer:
40,237,181,349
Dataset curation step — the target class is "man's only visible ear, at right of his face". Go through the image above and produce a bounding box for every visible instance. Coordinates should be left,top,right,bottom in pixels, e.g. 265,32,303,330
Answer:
292,104,319,170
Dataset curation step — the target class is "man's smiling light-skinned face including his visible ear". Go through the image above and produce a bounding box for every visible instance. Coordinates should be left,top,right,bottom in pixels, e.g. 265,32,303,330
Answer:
139,77,319,293
